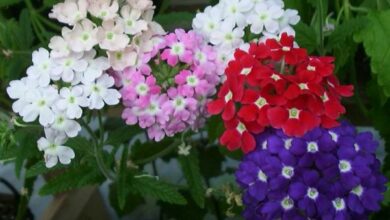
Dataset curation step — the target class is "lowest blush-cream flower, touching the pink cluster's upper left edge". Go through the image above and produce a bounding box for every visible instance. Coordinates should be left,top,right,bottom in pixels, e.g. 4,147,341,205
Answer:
107,46,138,71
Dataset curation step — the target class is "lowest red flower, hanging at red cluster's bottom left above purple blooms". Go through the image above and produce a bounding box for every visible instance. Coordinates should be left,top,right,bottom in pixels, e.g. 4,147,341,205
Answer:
220,119,264,153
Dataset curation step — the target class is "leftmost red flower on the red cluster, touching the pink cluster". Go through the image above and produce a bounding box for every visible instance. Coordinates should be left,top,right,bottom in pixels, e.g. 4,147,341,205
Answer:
207,77,243,121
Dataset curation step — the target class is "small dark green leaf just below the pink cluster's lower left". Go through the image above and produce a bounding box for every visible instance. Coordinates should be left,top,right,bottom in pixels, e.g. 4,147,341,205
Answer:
106,126,141,146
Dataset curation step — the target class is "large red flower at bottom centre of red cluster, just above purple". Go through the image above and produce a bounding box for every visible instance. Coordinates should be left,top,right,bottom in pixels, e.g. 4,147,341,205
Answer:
268,107,320,137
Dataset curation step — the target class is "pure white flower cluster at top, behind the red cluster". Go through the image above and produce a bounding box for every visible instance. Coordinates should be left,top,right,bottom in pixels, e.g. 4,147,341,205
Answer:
192,0,300,71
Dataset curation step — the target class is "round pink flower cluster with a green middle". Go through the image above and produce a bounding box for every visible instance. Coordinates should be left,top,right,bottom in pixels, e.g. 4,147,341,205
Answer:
114,29,221,141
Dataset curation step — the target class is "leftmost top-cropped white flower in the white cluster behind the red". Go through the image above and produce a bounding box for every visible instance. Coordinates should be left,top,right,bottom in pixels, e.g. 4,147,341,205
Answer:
221,0,253,27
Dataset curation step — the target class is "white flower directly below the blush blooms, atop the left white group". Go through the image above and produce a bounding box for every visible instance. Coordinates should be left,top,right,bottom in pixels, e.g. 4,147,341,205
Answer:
51,53,88,82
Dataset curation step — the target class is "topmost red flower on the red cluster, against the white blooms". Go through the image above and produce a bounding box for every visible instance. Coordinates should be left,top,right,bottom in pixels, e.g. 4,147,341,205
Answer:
266,33,307,65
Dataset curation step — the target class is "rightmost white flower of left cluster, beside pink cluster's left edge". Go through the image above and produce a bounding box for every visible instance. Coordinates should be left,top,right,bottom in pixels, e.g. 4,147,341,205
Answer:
84,74,121,109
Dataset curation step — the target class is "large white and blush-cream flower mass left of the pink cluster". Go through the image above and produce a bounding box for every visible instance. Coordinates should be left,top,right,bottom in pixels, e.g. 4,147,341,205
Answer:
7,0,164,168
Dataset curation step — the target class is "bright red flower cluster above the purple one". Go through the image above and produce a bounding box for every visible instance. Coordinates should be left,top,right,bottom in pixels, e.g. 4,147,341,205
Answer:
208,33,353,153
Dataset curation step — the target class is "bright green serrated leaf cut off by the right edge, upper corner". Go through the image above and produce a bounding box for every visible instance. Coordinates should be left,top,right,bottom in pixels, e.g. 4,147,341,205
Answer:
354,10,390,97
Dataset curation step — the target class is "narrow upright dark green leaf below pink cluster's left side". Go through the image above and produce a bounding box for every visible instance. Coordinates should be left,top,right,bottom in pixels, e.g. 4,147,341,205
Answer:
116,146,129,210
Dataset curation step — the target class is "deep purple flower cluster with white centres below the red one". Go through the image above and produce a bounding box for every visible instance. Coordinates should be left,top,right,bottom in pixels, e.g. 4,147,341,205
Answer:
236,123,386,220
